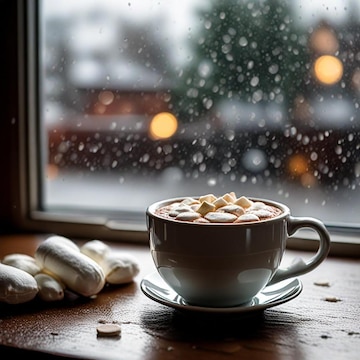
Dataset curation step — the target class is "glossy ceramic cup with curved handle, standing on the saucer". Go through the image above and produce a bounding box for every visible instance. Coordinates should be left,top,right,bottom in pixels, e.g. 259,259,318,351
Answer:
146,198,330,307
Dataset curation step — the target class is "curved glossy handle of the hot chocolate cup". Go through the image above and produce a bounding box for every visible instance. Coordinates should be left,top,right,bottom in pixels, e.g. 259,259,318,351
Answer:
268,216,330,285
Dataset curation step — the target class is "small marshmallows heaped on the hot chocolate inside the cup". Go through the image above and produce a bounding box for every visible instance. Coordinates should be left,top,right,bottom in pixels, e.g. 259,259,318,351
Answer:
157,192,281,223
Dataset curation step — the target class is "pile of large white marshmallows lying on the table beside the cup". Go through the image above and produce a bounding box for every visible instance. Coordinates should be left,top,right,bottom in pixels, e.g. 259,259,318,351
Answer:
0,236,140,304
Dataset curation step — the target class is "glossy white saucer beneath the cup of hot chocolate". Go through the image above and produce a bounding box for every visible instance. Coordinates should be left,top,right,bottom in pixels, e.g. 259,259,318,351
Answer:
140,272,303,314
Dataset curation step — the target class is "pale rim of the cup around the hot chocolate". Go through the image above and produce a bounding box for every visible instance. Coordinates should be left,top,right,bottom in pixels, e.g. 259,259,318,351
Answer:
146,196,290,226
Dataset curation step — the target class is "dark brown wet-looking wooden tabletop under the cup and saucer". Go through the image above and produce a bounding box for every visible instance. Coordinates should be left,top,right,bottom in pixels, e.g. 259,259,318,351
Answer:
0,235,360,360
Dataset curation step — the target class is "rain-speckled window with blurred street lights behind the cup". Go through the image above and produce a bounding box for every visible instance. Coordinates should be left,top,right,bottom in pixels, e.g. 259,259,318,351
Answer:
14,0,360,253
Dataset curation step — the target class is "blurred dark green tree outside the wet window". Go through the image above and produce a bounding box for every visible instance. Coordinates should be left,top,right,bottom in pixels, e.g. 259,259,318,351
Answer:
173,0,308,121
